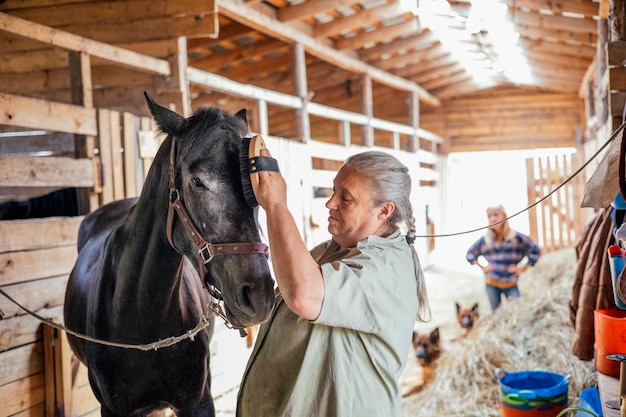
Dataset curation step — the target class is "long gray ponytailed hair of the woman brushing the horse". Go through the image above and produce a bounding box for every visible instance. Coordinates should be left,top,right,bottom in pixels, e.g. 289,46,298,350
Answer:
343,151,430,321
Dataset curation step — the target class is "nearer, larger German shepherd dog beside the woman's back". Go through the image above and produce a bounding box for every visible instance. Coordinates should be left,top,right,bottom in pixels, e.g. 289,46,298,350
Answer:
402,327,441,397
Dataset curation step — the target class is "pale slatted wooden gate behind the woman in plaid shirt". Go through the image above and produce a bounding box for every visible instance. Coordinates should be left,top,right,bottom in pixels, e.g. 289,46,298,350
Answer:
526,152,590,253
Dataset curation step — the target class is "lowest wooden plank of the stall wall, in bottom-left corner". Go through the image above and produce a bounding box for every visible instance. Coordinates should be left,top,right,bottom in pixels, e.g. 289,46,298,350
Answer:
0,373,44,416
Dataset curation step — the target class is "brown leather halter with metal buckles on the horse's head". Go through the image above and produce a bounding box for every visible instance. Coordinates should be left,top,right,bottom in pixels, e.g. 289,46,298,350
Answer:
167,137,269,299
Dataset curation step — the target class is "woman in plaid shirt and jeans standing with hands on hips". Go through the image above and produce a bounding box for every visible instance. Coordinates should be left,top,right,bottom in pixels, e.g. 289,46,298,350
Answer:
465,205,541,311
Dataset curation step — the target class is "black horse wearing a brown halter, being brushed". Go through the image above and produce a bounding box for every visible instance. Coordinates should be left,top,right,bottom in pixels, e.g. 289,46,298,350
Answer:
64,95,274,417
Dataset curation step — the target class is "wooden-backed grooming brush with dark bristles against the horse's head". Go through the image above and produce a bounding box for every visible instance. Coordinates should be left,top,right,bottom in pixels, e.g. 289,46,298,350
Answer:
239,135,280,207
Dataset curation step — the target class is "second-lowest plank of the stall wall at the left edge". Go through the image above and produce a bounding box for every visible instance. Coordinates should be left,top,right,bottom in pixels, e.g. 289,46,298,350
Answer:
0,342,44,386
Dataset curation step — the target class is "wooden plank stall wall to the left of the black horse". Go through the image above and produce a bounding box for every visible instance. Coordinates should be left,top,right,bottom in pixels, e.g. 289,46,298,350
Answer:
0,101,155,417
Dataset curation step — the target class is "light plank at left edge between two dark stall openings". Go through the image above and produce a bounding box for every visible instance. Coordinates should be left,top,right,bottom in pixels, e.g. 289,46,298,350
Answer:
0,155,93,188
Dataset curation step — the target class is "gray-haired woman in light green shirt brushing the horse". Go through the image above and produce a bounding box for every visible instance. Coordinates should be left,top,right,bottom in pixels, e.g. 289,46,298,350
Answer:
237,150,429,417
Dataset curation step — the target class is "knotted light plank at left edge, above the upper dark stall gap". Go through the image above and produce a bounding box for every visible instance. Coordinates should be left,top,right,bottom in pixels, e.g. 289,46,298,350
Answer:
0,93,97,136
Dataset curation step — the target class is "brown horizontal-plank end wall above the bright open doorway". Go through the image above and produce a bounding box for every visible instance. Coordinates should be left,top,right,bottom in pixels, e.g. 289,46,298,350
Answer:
420,87,584,154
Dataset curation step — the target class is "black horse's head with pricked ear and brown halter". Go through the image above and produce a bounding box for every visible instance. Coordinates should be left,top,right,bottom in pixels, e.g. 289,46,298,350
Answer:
146,94,274,328
